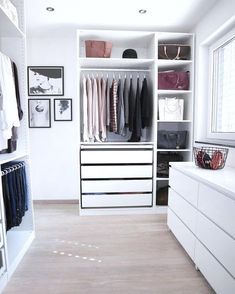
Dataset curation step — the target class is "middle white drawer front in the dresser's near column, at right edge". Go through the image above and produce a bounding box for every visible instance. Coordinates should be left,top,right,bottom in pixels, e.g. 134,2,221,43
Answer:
197,213,235,277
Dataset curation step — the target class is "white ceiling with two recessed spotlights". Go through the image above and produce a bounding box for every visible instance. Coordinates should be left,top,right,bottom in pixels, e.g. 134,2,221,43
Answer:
26,0,220,37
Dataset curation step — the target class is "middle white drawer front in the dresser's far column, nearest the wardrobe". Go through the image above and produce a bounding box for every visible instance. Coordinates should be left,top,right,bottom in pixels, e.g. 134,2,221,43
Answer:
168,189,197,234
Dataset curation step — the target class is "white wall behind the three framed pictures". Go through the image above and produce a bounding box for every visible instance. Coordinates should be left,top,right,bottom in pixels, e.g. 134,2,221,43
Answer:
27,34,79,200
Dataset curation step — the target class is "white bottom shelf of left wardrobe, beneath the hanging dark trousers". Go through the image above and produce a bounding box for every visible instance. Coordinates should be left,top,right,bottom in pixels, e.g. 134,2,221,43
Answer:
7,230,35,276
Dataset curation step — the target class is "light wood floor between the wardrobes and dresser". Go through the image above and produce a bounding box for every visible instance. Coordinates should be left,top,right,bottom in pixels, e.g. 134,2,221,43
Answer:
4,204,214,294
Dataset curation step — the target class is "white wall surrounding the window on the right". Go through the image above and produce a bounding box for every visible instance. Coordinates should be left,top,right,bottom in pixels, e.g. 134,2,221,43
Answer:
194,0,235,167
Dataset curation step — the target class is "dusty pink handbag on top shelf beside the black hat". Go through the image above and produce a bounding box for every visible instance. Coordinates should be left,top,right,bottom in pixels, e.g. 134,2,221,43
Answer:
85,40,113,58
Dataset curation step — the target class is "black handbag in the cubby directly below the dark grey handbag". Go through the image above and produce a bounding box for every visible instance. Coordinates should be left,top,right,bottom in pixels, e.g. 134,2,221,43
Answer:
157,152,183,178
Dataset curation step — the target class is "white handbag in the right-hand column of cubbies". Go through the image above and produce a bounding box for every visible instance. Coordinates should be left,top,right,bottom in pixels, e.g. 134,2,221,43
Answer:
159,97,184,121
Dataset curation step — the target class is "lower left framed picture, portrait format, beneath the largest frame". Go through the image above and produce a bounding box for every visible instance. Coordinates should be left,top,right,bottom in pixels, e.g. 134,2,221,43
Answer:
28,99,51,128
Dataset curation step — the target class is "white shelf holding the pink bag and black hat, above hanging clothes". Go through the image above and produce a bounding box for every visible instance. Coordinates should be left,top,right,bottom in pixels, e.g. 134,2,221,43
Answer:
79,58,154,71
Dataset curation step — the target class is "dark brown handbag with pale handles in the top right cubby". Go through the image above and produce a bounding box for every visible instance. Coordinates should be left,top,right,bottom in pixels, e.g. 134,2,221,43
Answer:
158,44,191,60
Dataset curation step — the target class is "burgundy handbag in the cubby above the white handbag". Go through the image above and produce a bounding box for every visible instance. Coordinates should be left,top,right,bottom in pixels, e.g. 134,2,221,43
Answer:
158,71,189,90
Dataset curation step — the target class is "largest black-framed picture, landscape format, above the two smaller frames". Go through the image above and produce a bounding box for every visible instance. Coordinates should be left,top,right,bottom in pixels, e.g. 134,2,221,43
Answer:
28,66,64,96
